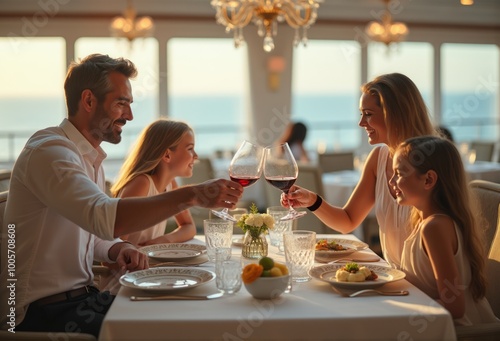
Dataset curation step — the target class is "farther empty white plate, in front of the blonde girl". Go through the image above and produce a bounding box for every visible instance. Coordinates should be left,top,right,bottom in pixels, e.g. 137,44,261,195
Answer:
139,243,207,261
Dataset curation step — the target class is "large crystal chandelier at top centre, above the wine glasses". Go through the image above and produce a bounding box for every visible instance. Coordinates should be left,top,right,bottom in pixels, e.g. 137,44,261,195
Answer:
211,0,323,52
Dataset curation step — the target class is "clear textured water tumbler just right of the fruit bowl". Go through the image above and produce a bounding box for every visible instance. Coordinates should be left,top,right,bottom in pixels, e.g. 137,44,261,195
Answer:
283,230,316,282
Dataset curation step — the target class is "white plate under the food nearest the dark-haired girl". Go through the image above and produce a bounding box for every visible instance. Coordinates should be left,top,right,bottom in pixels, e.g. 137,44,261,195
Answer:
309,264,406,290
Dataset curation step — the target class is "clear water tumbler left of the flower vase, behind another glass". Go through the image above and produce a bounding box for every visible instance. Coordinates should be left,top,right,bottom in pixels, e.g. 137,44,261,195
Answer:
203,219,233,262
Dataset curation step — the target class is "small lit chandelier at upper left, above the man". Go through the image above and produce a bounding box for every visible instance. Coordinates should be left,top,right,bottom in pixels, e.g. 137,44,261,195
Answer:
110,0,154,42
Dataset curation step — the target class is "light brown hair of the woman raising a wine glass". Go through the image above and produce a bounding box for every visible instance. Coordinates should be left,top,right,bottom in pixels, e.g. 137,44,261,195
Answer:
361,73,439,155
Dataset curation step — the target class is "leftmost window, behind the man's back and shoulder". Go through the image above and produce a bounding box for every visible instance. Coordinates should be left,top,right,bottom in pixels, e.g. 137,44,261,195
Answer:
0,38,66,162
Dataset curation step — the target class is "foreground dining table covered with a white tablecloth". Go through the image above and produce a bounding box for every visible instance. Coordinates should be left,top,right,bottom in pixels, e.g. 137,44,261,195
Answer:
99,234,456,341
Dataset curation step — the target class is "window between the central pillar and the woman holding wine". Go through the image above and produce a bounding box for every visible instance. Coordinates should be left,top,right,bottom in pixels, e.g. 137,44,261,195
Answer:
291,40,361,150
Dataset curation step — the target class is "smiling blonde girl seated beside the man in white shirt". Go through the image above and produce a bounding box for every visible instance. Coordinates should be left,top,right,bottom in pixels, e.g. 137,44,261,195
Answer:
100,119,198,294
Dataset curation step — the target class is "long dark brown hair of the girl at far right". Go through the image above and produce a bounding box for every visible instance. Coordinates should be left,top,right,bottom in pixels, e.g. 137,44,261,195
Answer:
397,136,486,300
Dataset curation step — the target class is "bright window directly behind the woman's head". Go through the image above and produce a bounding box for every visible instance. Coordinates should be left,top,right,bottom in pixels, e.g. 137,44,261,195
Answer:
368,42,435,116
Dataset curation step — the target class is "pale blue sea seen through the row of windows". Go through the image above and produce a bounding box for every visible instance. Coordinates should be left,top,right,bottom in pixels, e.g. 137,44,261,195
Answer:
0,93,498,162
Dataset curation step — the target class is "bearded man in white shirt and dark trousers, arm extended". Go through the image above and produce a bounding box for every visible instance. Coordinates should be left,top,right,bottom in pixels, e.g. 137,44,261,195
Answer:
1,54,243,337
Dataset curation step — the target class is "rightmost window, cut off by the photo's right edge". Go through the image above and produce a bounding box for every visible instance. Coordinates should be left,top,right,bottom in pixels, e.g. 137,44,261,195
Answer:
441,44,500,142
